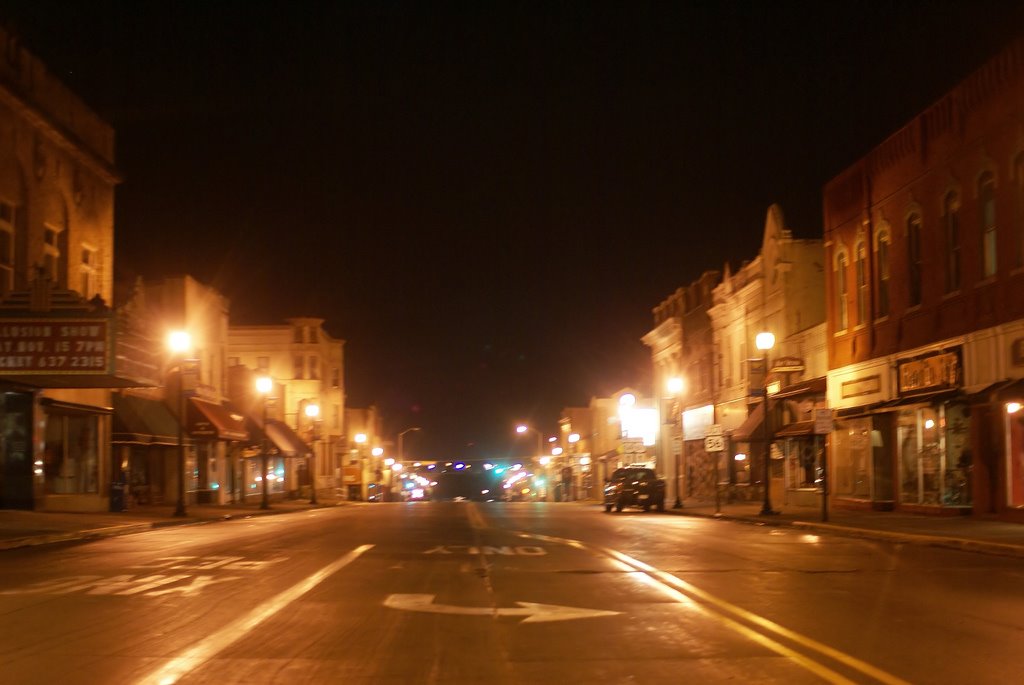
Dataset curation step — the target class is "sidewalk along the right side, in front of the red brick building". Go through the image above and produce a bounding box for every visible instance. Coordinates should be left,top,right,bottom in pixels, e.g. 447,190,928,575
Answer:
666,501,1024,558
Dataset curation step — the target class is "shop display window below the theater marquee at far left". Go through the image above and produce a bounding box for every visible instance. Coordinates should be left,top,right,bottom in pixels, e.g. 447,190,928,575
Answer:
43,414,99,495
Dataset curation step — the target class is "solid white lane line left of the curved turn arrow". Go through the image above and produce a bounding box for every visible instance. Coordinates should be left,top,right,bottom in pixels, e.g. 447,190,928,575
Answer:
136,545,374,685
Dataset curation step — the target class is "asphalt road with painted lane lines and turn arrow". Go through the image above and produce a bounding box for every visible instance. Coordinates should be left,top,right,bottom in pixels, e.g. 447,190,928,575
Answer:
0,503,1024,685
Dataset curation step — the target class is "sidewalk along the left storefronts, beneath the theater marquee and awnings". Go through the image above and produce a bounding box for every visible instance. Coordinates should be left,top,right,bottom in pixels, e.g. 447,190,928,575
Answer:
0,494,347,551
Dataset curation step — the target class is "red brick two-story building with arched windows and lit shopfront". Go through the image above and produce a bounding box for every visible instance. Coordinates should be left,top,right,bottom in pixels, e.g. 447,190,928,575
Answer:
823,40,1024,520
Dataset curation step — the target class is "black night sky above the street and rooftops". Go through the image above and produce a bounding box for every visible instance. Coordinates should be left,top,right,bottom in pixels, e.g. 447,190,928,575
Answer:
0,0,1024,458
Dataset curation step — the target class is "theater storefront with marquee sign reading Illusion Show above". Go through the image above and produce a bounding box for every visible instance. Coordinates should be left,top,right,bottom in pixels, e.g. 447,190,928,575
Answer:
0,292,155,511
